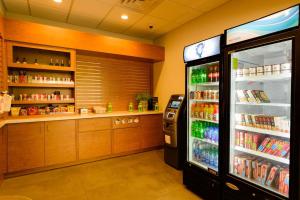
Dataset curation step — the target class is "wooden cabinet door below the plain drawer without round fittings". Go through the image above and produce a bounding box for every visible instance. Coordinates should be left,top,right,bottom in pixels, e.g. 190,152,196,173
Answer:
78,130,111,160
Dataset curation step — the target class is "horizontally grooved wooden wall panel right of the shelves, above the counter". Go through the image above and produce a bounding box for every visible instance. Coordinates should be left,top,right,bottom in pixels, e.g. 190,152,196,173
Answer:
76,55,152,111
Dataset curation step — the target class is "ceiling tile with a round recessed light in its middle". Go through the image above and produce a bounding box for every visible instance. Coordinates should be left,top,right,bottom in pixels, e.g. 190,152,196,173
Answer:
99,6,144,33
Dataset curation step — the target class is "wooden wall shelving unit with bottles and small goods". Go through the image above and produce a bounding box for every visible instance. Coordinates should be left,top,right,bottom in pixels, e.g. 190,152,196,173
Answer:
6,42,76,115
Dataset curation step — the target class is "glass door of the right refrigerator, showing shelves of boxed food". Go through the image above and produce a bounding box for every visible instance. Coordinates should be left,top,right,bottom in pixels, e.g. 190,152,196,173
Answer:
230,40,293,197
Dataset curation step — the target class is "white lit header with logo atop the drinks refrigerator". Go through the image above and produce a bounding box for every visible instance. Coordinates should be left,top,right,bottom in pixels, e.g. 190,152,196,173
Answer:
183,35,221,63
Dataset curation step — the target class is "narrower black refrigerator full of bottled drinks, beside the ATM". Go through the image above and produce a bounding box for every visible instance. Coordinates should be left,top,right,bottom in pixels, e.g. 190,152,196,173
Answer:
183,35,222,199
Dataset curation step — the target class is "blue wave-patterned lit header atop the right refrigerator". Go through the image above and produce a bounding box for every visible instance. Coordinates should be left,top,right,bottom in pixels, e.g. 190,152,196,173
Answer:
225,5,299,45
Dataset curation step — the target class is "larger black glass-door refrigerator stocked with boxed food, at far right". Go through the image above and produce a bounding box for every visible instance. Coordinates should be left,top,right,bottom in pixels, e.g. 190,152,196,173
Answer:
223,5,300,200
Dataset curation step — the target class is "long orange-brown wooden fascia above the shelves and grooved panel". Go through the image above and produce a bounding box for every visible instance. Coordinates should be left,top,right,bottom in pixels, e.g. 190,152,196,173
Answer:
4,19,165,62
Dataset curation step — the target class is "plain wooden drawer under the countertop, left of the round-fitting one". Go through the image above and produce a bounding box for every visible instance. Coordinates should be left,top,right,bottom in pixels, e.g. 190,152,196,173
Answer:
78,118,111,132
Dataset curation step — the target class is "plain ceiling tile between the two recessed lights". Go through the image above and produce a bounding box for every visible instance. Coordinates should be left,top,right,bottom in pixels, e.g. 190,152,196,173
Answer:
68,0,112,28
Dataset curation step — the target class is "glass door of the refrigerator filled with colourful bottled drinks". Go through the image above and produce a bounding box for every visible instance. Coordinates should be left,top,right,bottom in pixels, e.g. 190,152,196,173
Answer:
187,62,219,174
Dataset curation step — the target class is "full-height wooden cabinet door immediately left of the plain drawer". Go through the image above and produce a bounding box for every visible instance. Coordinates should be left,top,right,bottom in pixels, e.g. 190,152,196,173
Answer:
45,120,76,165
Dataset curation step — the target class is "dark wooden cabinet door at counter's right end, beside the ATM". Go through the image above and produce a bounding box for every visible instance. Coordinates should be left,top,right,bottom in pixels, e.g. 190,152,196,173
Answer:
141,114,164,148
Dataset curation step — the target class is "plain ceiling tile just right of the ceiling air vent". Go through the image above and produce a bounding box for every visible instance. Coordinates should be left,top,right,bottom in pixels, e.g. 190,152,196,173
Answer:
149,0,190,22
